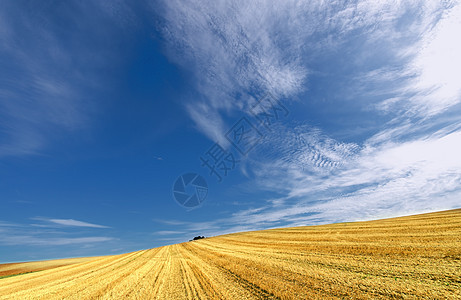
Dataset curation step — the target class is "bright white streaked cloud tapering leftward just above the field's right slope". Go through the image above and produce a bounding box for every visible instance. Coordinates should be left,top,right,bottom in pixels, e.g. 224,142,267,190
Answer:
234,126,461,226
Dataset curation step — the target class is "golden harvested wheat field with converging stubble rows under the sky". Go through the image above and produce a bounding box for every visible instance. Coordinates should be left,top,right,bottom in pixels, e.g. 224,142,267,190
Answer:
0,209,461,299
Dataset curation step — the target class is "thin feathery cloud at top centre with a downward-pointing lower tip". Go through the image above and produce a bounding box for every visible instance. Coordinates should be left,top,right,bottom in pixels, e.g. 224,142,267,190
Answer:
155,1,307,143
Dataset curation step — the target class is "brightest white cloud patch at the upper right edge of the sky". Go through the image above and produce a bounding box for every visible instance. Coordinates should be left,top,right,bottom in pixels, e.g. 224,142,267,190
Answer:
357,1,461,118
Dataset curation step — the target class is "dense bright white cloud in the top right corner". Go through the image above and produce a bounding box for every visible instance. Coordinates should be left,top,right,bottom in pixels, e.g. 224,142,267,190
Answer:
365,1,461,117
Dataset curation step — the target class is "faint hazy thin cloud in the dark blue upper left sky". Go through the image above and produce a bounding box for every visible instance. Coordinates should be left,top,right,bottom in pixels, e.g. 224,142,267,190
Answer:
0,2,130,157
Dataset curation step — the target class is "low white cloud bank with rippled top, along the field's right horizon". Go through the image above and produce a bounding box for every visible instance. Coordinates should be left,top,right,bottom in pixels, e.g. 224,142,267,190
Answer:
162,120,461,236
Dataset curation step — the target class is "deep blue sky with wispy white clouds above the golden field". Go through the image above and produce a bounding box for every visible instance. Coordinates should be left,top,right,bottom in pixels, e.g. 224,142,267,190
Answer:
0,0,461,262
